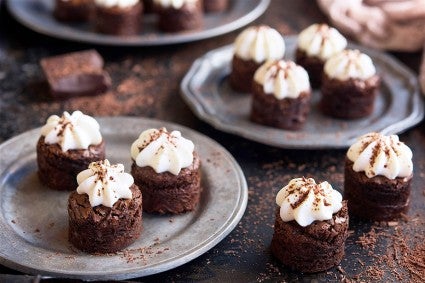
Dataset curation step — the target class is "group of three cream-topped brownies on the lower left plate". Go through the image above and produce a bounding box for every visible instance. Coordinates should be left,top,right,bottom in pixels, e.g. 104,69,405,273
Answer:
37,111,202,253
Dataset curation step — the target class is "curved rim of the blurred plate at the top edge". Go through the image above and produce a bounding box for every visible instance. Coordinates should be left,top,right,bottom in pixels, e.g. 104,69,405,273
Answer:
6,0,271,47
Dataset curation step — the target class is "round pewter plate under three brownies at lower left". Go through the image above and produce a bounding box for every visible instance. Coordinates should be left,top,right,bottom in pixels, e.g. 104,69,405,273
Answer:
0,117,248,280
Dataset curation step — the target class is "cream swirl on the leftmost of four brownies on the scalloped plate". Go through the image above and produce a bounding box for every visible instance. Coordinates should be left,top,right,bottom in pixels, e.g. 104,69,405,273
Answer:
234,25,285,63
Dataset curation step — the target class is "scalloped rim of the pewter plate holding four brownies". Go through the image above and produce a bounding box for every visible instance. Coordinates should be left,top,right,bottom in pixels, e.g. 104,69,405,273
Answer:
180,35,424,150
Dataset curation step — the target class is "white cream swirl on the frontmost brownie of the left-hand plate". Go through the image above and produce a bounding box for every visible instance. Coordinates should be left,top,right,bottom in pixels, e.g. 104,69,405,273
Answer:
77,159,134,207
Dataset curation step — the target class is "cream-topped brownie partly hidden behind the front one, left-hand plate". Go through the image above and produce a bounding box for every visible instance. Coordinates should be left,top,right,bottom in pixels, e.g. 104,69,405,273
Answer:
37,111,105,191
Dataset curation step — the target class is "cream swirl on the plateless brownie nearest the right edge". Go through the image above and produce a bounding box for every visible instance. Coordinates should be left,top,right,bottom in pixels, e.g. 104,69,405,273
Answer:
347,133,413,179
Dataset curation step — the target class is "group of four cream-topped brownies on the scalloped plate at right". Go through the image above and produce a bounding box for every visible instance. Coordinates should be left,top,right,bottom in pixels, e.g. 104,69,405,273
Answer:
229,24,380,130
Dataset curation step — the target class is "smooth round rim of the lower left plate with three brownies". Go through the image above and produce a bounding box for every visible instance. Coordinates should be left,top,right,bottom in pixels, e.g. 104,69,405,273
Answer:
0,116,248,280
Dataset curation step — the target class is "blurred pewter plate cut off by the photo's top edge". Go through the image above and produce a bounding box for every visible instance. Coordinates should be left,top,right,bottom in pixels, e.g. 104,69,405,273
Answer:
7,0,270,46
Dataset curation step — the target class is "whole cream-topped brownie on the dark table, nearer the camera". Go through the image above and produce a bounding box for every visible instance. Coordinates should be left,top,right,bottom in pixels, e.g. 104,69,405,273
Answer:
271,178,349,273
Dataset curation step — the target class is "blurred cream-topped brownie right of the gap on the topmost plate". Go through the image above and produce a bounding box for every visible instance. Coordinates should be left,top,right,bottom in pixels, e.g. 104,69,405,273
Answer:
154,0,204,32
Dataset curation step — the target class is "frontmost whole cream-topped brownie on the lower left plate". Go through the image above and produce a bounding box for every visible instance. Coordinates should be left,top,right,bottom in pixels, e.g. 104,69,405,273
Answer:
68,159,142,253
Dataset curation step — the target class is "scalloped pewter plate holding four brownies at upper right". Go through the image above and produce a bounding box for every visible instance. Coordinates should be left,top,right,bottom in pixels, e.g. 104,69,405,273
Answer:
181,36,424,149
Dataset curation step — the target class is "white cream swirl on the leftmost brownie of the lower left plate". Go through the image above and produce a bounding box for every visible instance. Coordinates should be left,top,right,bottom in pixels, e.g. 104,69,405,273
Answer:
41,111,102,152
